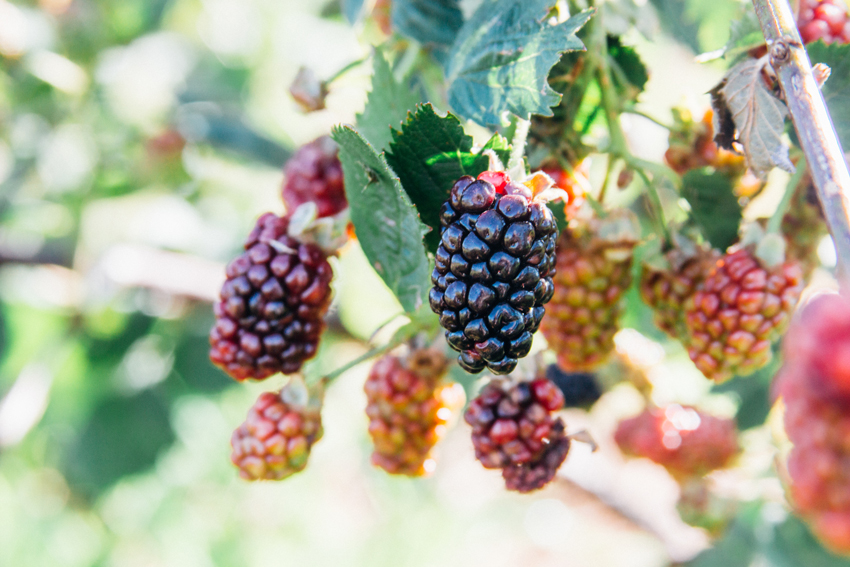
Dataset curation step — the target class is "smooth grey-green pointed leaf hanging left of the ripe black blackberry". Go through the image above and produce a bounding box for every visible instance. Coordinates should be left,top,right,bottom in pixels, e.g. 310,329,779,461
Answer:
333,126,430,312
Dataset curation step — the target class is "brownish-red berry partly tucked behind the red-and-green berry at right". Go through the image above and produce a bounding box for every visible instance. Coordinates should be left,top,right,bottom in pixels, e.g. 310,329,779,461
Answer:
640,247,720,338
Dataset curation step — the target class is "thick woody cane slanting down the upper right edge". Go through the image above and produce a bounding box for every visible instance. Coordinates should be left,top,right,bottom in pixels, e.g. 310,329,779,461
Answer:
753,0,850,279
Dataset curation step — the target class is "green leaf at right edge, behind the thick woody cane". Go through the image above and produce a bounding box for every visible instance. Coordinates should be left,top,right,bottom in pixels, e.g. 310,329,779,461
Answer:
806,40,850,151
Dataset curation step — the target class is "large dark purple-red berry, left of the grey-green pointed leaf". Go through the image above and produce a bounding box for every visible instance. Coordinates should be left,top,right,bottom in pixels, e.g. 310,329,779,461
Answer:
210,213,333,381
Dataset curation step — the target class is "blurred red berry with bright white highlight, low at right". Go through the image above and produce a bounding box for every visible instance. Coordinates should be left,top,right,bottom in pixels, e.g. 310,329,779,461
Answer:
614,404,738,480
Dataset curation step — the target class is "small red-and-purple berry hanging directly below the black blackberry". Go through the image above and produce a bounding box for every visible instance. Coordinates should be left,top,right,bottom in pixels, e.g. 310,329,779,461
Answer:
464,378,570,492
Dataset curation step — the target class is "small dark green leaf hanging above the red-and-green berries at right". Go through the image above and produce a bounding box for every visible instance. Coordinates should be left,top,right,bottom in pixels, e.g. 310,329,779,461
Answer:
682,168,741,250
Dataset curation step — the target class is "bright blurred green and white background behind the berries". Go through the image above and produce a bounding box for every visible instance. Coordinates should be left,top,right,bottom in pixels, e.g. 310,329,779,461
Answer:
0,0,844,567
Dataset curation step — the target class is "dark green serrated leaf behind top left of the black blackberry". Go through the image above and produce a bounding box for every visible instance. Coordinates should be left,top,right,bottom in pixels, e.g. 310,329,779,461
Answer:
387,104,510,252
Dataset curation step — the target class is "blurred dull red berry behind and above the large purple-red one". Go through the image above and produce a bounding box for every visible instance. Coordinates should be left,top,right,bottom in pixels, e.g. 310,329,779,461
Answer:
282,136,348,217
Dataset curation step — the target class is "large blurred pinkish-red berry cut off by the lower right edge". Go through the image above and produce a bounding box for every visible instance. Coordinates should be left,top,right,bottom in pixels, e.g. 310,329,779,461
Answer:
776,294,850,553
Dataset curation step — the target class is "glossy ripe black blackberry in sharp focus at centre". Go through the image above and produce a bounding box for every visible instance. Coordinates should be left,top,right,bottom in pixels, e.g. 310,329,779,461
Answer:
429,171,558,374
